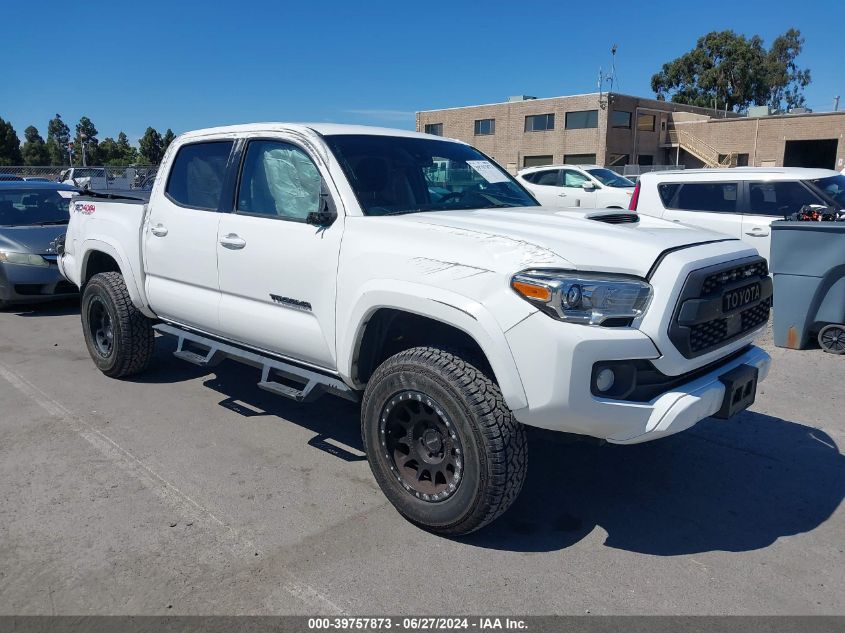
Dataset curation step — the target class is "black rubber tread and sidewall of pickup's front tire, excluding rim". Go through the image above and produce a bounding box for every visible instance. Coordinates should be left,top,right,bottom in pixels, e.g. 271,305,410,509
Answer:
361,347,527,536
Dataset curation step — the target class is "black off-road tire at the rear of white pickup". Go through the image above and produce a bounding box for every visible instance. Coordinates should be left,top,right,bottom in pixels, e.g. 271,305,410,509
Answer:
81,272,155,378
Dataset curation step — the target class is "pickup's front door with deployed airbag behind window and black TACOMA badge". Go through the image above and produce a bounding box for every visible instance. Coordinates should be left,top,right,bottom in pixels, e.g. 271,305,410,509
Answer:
217,139,343,369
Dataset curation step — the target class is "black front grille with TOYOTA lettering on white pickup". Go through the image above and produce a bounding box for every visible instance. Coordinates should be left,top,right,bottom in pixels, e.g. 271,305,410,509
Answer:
669,257,772,358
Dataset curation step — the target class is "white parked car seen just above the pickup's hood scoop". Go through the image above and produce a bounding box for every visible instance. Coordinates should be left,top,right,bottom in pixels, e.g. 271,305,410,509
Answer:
516,165,634,209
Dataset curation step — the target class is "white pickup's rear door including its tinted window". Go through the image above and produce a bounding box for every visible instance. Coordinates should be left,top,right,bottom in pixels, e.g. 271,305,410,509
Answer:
144,140,233,333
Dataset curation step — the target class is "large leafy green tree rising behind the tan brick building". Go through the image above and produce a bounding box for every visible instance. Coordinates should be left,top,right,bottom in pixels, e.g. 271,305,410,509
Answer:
651,29,810,111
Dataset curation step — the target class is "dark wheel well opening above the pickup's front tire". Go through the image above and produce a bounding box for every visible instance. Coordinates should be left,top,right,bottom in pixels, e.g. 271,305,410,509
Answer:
354,308,495,383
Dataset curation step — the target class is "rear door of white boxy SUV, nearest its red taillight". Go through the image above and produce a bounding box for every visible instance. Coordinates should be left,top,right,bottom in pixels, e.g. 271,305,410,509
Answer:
657,181,742,239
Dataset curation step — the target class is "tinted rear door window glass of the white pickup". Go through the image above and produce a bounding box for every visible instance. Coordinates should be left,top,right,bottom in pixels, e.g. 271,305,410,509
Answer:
165,141,233,211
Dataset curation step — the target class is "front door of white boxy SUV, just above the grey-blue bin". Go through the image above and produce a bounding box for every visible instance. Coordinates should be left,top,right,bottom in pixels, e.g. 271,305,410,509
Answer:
741,180,824,259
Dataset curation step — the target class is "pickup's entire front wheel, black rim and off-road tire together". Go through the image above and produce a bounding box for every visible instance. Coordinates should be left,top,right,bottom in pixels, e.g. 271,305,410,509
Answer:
361,347,527,535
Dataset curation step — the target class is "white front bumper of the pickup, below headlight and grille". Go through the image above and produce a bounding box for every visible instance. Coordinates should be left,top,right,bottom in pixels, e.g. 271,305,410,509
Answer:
506,313,771,444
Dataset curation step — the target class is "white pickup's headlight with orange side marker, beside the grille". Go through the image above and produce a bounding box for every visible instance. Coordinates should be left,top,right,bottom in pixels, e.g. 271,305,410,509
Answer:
511,270,652,325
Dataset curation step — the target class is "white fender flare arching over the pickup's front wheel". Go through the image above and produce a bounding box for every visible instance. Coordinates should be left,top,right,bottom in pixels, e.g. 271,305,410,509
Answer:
337,279,528,411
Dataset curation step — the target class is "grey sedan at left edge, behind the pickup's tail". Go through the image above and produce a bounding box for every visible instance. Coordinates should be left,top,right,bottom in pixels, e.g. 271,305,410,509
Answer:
0,182,78,308
